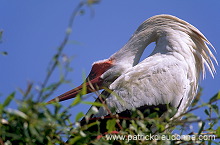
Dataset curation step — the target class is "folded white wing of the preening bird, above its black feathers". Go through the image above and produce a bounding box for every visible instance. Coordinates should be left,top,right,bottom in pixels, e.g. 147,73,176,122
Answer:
94,55,192,117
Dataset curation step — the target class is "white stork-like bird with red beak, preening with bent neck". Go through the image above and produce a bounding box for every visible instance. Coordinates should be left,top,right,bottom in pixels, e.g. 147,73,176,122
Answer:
47,15,217,131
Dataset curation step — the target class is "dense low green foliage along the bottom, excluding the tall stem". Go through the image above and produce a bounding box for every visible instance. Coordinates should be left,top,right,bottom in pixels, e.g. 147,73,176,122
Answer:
0,90,220,144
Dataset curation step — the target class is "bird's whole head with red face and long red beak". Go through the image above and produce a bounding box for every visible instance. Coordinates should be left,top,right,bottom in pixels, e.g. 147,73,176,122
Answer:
48,58,124,103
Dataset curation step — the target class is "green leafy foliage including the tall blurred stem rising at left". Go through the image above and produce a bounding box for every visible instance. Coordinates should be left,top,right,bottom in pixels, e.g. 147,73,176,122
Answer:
0,0,220,145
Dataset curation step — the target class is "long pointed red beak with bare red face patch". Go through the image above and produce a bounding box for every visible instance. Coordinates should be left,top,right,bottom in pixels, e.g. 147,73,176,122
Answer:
47,60,112,103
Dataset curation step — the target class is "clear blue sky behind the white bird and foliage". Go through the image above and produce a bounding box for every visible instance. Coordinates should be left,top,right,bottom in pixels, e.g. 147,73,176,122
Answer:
0,0,220,131
